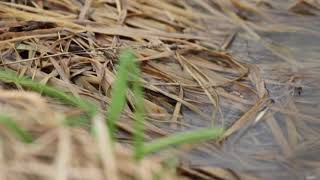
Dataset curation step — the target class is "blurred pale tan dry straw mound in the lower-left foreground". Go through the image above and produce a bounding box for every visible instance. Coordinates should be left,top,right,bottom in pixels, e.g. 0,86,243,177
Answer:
0,90,179,179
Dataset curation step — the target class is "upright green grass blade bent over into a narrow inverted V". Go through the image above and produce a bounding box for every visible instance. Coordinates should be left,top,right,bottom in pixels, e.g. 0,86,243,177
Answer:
107,49,145,159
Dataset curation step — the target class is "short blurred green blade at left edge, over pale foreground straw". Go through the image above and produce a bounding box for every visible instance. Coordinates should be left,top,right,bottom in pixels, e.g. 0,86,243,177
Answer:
0,114,33,143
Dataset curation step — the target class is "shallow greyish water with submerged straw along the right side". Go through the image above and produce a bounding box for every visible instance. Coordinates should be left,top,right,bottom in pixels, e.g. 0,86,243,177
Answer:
184,1,320,180
